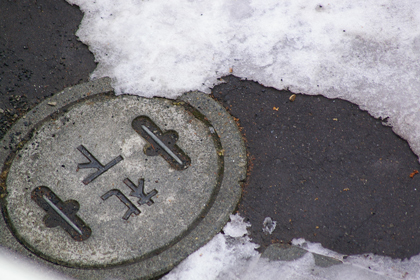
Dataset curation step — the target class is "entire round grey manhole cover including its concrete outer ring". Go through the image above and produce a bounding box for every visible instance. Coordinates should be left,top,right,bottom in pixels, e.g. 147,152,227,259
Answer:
0,79,246,279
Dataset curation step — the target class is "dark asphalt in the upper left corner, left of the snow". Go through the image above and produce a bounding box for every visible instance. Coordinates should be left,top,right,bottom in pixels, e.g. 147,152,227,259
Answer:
0,0,96,138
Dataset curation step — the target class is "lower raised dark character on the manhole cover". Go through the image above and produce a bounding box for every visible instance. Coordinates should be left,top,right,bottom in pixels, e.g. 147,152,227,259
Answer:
101,178,158,220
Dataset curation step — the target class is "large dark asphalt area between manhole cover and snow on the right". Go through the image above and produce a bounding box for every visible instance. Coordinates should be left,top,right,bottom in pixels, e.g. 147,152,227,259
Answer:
213,76,420,258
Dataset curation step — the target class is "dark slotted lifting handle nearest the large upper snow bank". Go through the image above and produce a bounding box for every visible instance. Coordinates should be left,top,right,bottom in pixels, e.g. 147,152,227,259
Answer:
131,116,191,170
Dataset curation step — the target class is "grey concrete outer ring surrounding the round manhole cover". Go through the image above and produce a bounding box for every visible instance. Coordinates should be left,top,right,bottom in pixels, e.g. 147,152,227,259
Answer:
0,78,247,279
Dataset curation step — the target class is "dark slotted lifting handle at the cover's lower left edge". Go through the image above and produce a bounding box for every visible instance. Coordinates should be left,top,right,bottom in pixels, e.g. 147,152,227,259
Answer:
31,186,92,241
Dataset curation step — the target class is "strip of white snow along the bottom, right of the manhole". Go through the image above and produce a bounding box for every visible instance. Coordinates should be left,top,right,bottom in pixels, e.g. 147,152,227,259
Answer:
163,215,420,280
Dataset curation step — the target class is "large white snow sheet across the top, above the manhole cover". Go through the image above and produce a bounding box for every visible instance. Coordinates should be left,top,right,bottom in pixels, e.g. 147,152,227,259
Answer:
68,0,420,162
